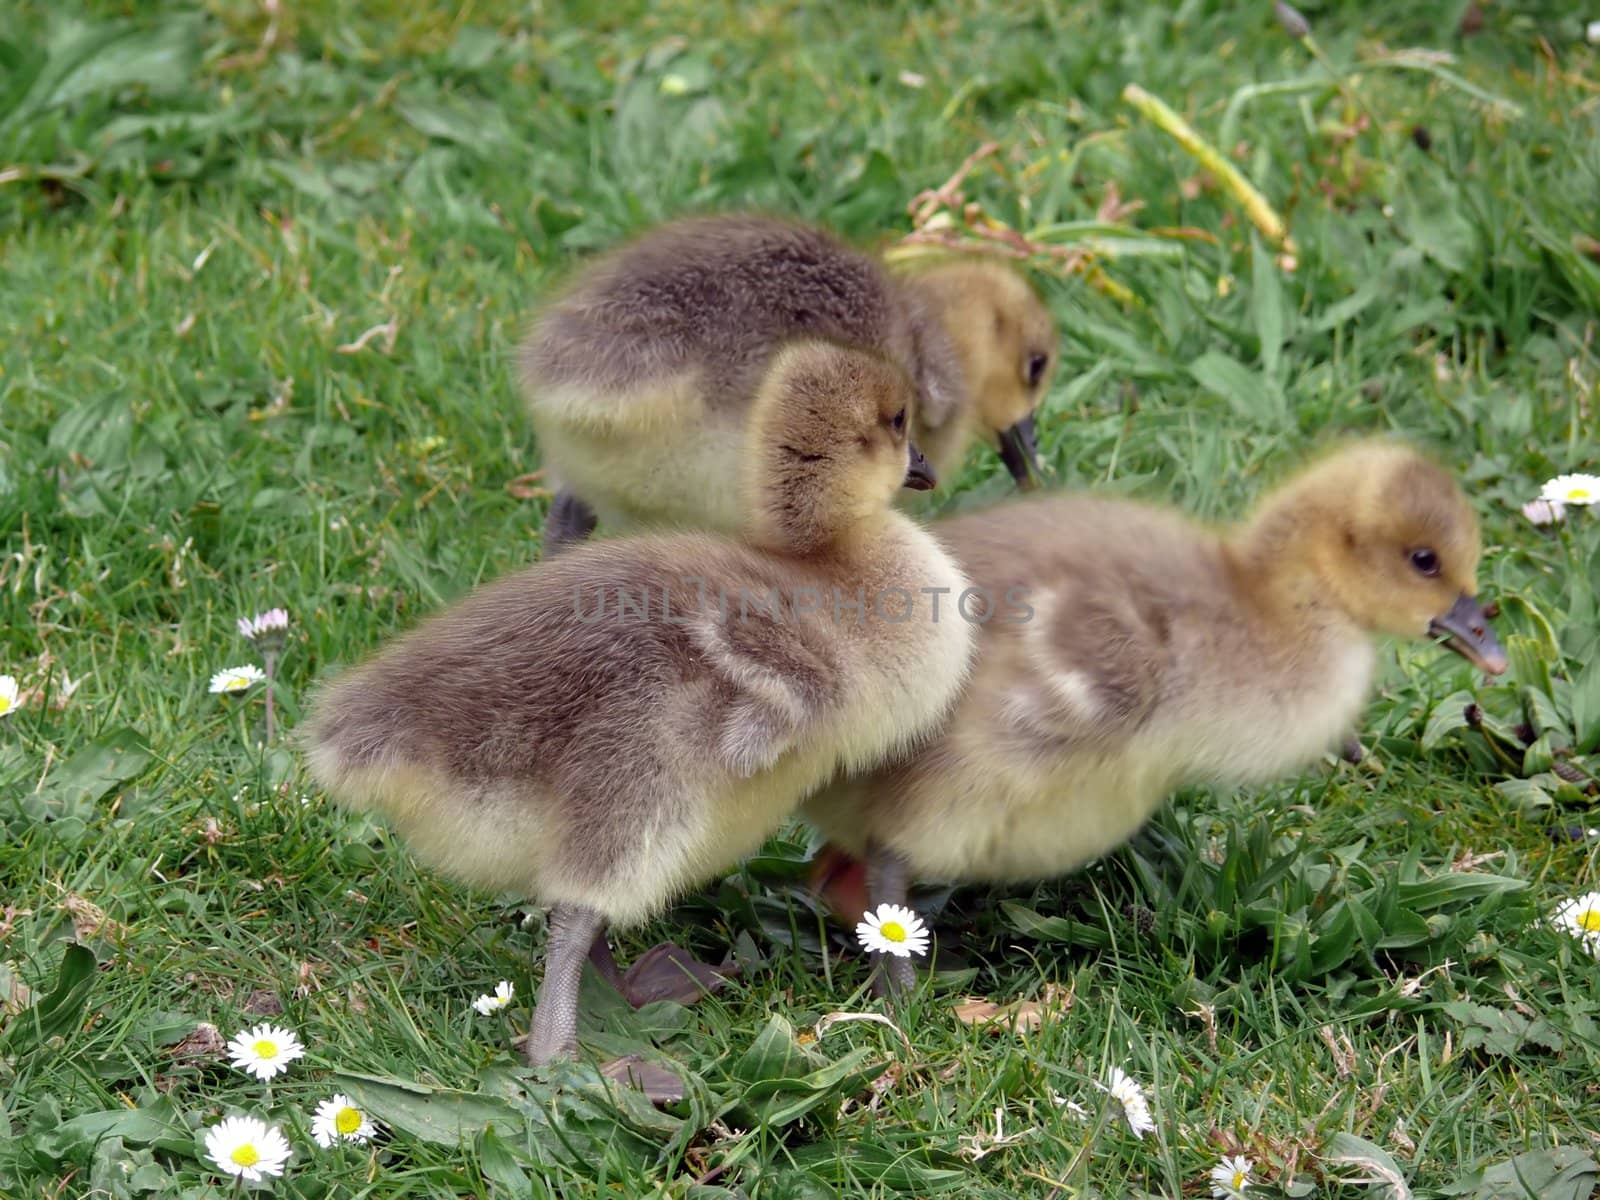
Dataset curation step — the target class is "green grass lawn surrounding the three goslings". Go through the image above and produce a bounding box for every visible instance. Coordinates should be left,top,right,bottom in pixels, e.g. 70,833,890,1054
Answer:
0,0,1600,1200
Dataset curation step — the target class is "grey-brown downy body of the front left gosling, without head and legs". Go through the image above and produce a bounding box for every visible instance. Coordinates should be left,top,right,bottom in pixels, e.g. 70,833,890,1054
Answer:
307,531,970,922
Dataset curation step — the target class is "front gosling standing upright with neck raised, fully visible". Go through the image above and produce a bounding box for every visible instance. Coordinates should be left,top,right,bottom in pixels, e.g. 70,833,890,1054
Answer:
307,342,973,1064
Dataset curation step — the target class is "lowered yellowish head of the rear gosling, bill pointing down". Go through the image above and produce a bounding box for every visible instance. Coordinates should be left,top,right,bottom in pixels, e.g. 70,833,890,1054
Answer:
912,259,1056,488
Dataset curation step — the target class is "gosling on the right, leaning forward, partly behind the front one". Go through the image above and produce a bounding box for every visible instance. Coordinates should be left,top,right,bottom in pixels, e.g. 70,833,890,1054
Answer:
803,442,1506,984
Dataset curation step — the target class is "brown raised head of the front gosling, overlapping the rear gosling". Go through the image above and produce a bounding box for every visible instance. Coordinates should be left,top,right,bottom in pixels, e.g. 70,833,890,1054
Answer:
744,341,934,550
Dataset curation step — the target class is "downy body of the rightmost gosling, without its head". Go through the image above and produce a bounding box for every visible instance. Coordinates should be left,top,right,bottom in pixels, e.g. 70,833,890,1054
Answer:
806,496,1374,882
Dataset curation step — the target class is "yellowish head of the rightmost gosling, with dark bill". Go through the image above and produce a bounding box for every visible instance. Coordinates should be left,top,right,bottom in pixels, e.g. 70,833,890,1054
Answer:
1254,442,1506,675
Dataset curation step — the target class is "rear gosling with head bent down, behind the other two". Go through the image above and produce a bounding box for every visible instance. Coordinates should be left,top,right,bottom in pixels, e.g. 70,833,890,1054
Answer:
522,216,1056,552
